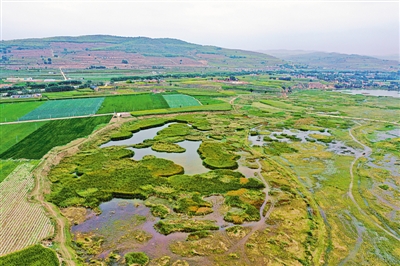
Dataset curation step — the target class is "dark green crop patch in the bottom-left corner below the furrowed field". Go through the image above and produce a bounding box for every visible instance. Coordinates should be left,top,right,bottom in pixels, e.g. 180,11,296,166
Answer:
0,245,60,266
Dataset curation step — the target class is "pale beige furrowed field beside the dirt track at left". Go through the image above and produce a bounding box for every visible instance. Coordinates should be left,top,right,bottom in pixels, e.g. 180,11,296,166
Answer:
0,162,54,256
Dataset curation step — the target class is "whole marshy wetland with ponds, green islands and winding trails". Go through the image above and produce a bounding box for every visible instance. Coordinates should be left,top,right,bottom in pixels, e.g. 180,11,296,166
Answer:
48,91,400,265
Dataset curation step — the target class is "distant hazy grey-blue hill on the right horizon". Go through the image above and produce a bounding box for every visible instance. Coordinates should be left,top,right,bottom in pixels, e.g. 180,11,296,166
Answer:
259,50,399,71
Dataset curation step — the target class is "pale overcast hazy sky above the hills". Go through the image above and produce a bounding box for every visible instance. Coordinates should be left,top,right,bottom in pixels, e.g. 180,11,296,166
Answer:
1,0,399,55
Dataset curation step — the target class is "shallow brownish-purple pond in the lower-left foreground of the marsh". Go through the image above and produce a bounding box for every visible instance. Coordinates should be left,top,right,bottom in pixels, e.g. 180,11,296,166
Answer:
71,198,188,257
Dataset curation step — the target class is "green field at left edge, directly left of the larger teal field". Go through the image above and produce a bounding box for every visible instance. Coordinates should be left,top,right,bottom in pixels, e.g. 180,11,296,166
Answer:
0,101,44,122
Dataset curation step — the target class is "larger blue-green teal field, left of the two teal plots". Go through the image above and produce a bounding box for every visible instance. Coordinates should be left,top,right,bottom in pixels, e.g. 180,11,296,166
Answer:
20,98,104,120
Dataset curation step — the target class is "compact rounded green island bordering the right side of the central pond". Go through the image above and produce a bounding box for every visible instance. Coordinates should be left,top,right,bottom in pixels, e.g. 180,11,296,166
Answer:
198,141,240,169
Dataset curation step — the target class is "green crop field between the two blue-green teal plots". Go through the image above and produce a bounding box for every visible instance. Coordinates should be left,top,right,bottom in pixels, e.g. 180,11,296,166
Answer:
98,94,168,114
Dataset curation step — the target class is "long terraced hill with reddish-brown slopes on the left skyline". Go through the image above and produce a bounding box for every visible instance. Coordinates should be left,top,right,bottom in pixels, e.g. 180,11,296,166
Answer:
0,35,282,69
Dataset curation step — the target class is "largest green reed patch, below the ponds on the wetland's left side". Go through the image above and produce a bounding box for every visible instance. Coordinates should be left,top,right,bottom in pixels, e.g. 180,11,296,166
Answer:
48,147,183,208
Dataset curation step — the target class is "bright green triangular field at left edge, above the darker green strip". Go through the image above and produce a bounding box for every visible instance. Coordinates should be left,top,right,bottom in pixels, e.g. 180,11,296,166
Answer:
0,121,47,154
